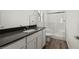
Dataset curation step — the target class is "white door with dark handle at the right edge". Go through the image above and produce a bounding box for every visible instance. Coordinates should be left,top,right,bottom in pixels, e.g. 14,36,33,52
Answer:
66,10,79,49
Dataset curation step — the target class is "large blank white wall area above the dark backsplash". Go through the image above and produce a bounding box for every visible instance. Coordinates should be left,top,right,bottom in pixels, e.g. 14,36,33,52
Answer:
0,10,33,28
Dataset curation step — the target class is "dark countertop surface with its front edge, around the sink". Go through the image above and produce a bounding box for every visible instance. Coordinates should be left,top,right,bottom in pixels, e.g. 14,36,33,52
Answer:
0,27,45,48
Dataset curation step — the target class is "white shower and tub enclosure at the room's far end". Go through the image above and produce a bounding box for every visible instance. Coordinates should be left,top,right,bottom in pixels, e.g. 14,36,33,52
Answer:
45,11,66,40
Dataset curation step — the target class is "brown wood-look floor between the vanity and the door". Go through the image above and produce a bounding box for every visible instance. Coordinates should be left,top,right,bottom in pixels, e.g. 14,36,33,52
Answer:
44,38,68,49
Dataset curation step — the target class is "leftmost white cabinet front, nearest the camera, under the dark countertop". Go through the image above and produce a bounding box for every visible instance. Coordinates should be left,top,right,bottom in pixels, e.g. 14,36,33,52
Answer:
2,38,26,49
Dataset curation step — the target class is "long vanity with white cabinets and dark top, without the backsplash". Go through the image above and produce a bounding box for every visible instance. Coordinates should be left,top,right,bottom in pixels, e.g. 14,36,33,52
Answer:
0,27,46,49
